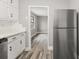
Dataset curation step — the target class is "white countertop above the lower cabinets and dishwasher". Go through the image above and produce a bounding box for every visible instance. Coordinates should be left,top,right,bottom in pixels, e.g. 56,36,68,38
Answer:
0,24,26,38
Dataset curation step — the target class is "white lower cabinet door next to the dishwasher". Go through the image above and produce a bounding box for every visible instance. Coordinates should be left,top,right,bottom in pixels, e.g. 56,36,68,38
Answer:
8,39,20,59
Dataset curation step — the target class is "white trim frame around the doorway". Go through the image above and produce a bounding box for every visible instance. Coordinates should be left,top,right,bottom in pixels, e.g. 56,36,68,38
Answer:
28,5,49,49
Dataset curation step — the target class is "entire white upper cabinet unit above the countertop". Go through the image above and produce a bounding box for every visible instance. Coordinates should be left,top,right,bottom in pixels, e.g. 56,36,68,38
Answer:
0,0,18,20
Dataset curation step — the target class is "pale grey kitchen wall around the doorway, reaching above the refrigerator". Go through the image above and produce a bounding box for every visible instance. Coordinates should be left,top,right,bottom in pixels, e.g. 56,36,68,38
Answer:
19,0,69,46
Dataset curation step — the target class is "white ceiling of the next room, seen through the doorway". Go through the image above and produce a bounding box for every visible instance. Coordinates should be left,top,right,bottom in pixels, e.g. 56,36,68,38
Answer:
31,7,48,16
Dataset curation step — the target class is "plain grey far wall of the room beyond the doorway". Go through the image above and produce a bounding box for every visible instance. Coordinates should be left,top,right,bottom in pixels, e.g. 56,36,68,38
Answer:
37,16,48,33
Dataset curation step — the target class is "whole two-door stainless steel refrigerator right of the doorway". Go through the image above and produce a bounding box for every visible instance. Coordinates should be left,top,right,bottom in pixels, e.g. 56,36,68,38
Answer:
53,9,77,59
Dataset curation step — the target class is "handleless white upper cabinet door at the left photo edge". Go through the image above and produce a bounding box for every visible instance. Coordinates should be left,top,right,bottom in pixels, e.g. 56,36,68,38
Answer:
0,2,9,20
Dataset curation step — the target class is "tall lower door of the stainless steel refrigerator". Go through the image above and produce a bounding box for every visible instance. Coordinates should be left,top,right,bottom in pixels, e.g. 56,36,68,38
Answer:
54,29,77,59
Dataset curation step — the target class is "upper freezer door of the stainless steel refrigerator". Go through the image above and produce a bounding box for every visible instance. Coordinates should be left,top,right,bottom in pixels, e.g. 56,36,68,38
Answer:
54,9,77,28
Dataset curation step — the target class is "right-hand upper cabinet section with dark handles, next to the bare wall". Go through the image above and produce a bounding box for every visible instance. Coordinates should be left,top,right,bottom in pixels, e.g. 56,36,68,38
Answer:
9,0,18,21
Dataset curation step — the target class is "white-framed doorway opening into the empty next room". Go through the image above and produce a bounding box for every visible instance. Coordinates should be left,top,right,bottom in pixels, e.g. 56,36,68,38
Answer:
29,6,49,48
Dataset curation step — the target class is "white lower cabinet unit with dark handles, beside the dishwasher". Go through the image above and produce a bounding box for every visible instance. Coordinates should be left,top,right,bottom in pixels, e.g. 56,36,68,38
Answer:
8,32,25,59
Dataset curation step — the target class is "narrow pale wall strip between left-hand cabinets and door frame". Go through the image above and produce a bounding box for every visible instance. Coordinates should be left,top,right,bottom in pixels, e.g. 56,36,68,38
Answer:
19,0,29,49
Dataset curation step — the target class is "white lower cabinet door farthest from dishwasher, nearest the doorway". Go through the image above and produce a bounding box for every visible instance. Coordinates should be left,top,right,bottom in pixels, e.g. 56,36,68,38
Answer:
14,39,25,57
